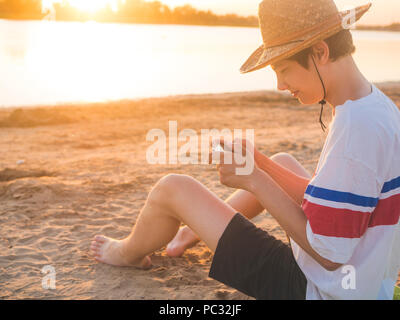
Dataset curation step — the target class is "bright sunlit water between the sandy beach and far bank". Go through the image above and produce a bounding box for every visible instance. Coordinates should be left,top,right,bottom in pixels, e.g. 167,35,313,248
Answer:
0,20,400,107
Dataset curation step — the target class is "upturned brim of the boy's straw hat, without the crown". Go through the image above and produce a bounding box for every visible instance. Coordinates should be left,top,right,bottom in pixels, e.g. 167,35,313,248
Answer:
240,3,371,73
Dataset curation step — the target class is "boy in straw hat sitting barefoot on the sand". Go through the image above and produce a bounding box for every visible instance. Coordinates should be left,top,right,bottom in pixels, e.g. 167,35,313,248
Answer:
91,0,400,299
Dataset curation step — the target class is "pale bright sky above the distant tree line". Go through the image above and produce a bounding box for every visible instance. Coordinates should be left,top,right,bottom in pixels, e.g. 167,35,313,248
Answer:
153,0,400,25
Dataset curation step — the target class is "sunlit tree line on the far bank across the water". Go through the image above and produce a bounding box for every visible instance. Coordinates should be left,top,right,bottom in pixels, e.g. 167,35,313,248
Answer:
0,0,400,31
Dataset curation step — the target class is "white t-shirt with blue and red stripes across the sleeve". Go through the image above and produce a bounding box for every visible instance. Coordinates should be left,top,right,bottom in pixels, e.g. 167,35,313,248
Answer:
290,85,400,299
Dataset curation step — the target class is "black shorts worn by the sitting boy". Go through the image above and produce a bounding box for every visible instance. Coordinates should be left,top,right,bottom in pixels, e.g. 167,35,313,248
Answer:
209,213,307,300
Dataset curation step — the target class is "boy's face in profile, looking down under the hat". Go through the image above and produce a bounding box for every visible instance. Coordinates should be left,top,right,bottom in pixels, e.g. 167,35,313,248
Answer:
271,57,323,104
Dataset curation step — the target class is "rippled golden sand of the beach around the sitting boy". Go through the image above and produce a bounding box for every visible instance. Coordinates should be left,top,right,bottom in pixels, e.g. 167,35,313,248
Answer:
0,83,400,300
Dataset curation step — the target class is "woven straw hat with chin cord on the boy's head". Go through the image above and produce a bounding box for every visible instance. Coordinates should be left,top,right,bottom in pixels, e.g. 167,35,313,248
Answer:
240,0,371,73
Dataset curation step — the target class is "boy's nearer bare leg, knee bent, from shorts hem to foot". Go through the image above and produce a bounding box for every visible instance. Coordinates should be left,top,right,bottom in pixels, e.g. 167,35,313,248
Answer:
91,174,236,268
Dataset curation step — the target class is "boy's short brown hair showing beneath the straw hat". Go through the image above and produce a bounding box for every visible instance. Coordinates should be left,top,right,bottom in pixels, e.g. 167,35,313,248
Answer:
288,29,356,69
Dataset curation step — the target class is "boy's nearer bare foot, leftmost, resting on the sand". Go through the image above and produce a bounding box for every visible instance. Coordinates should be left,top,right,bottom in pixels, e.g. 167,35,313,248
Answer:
90,235,151,269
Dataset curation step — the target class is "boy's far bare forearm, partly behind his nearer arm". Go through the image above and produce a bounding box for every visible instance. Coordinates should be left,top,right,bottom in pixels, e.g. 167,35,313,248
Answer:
254,150,310,205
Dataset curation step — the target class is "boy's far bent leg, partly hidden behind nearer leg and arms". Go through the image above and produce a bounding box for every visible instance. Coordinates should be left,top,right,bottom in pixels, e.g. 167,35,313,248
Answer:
166,152,311,257
